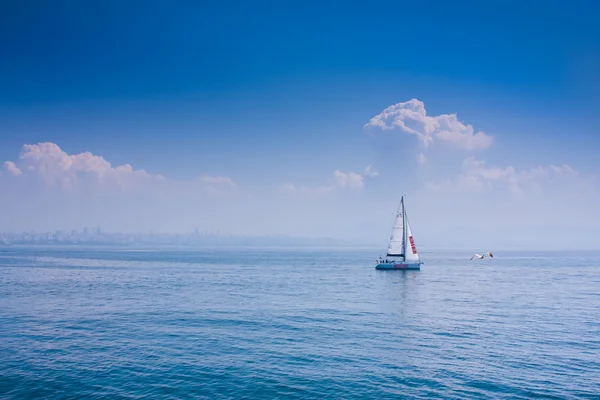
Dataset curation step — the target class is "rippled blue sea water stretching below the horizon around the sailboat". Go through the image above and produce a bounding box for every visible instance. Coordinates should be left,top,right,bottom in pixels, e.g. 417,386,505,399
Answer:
0,247,600,399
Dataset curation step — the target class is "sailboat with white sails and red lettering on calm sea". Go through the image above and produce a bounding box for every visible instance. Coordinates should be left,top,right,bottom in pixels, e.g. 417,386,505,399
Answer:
375,196,423,270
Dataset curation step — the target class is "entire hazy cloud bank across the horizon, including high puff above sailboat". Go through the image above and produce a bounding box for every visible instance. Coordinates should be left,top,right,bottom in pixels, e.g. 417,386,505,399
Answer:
0,111,600,248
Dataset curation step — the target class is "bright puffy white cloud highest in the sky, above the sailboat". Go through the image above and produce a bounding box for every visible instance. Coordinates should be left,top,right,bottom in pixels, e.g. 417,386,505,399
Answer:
365,99,493,150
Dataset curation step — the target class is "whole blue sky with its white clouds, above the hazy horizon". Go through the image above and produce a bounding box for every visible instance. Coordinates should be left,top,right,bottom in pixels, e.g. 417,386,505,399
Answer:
0,1,600,251
